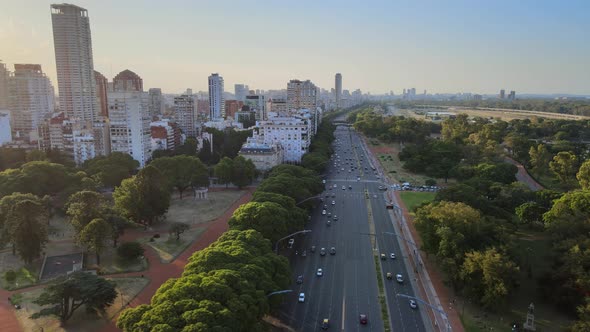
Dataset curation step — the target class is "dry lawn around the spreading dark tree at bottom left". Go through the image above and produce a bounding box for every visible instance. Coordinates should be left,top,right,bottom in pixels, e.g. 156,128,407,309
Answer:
11,278,149,332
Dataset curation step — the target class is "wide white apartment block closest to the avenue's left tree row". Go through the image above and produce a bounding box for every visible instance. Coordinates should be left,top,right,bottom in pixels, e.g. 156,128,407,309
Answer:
253,117,312,163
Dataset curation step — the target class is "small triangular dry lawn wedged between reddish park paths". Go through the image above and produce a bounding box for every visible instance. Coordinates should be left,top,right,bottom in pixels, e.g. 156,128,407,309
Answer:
138,227,206,263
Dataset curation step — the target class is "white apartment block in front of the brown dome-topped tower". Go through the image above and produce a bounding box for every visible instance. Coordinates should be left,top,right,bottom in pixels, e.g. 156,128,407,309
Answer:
107,91,151,167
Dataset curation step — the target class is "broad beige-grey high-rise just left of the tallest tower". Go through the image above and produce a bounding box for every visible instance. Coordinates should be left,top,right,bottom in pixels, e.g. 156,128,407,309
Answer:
8,64,55,142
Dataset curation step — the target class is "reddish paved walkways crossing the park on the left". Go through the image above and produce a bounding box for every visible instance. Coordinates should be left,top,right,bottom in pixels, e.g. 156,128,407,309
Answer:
0,187,255,332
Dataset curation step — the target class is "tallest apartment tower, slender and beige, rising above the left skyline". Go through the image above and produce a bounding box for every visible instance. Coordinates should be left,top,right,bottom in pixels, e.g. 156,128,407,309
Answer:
51,4,98,122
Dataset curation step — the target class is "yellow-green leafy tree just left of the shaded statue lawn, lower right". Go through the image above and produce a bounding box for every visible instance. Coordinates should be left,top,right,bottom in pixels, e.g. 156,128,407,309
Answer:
461,248,519,309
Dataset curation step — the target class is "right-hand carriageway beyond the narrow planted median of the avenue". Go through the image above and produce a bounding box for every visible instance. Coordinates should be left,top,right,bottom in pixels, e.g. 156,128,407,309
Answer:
372,184,425,331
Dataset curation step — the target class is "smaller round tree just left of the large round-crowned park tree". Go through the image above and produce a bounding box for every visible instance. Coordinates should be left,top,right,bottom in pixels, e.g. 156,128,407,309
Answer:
65,190,107,234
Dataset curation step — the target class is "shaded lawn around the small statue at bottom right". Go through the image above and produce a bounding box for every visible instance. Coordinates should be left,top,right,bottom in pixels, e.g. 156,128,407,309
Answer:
457,231,573,332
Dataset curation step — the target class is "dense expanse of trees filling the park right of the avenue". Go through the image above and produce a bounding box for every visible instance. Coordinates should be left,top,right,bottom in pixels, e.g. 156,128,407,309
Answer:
349,109,590,331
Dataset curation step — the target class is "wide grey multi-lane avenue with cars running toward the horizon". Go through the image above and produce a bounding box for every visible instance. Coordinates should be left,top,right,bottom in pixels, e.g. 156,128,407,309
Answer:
280,126,432,331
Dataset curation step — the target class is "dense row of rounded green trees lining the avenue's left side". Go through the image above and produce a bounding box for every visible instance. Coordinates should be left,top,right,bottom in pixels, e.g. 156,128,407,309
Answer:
117,118,333,331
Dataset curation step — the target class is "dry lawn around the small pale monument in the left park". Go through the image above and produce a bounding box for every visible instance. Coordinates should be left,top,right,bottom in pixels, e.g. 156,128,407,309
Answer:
166,190,246,225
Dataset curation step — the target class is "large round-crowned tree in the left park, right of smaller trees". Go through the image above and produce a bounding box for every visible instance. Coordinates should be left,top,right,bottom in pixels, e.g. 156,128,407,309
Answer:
113,165,170,225
